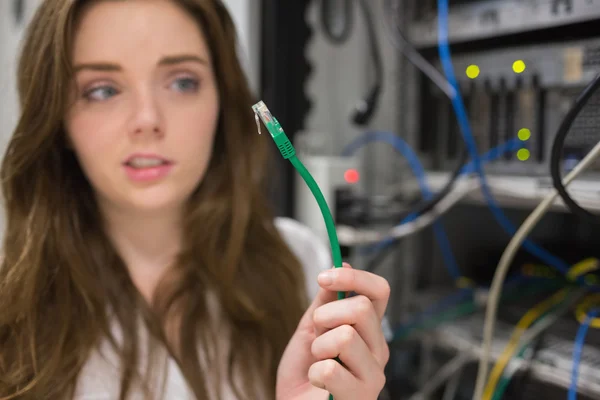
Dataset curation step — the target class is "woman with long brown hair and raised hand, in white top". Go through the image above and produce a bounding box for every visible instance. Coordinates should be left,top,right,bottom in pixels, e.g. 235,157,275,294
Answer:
0,0,389,400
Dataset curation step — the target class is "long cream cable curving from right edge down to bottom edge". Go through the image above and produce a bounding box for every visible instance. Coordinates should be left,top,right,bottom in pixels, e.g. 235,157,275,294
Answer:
473,142,600,400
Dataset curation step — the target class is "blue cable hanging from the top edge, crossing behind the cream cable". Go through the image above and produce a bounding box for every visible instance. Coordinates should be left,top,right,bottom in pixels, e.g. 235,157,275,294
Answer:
437,0,569,273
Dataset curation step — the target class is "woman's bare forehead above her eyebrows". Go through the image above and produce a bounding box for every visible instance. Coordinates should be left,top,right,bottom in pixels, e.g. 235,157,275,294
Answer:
73,0,209,63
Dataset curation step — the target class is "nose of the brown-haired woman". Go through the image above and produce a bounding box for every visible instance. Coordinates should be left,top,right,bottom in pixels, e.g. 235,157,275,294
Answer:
130,91,164,138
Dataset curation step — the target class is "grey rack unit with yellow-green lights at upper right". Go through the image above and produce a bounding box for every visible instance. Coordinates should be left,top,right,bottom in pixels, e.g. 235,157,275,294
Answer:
418,39,600,176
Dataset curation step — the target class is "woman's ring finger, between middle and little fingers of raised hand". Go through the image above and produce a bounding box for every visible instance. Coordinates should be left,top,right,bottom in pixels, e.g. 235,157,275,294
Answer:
311,325,383,382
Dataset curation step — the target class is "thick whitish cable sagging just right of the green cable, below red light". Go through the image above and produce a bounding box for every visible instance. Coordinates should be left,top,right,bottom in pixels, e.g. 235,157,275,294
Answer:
337,178,479,246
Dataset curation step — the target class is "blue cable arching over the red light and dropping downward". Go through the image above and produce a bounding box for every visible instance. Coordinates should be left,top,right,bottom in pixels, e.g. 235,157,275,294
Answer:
342,132,461,280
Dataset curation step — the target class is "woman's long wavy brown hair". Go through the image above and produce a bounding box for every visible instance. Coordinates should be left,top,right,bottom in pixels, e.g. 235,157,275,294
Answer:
0,0,306,400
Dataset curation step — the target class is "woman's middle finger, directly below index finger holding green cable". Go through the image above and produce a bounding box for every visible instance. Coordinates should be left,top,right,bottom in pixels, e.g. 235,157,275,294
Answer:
313,295,389,366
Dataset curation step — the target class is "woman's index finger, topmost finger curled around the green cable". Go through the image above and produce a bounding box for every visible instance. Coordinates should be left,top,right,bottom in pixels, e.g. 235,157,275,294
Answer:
318,268,390,319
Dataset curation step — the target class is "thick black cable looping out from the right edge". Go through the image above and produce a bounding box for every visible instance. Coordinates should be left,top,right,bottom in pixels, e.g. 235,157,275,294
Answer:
550,74,600,223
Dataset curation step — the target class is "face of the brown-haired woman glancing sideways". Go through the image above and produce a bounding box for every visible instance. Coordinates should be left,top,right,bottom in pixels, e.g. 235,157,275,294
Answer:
66,0,219,216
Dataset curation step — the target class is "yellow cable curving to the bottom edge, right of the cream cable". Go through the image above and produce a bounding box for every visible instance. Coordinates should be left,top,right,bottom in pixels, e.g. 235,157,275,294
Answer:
482,289,569,400
